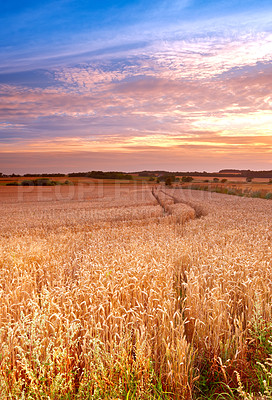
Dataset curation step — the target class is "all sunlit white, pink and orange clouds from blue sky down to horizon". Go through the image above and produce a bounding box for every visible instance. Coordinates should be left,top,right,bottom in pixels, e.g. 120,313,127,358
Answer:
0,3,272,172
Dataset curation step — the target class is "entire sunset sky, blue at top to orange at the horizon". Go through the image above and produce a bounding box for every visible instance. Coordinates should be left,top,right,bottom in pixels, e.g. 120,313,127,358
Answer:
0,0,272,174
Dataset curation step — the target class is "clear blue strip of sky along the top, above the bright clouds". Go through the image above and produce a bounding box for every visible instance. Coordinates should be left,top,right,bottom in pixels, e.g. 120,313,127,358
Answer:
0,0,272,72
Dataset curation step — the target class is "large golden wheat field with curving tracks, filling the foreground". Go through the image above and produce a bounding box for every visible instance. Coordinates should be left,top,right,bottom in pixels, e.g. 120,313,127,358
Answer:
0,183,272,400
